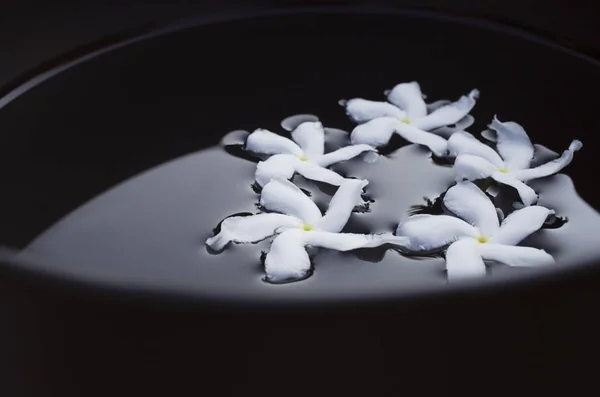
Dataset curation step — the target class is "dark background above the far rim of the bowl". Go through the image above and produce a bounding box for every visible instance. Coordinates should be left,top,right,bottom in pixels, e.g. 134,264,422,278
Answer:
0,0,600,87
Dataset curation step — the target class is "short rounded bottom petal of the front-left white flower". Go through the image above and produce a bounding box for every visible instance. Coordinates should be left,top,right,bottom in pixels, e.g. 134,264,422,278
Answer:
265,230,311,283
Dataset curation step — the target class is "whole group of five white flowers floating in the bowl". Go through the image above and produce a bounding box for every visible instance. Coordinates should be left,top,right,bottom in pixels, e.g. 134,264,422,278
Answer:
206,82,582,283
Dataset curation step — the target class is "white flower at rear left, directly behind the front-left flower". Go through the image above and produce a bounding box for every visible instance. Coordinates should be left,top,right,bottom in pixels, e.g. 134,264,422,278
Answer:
246,121,376,187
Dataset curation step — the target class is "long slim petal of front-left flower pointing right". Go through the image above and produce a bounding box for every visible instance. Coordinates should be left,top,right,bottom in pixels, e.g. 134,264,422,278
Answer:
305,230,407,251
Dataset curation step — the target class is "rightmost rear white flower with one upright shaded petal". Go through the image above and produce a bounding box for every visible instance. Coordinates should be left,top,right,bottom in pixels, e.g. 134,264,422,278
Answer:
449,117,582,206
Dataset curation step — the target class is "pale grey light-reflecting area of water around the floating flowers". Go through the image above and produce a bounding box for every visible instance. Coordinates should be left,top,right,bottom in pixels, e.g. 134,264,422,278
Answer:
12,119,600,300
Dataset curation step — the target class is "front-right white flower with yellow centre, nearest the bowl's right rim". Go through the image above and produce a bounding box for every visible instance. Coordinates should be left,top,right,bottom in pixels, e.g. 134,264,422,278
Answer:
396,181,554,279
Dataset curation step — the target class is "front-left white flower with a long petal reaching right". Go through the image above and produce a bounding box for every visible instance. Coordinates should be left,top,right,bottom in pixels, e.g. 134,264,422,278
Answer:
206,177,406,283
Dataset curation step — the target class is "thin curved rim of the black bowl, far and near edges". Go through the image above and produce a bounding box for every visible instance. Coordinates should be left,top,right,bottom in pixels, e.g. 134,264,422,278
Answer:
0,4,600,311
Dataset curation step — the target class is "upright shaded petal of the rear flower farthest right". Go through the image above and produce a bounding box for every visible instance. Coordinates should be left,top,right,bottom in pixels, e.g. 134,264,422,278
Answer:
488,116,533,171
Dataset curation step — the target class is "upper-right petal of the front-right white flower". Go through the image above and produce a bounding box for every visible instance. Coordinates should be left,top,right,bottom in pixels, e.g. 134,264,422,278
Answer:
490,205,554,245
